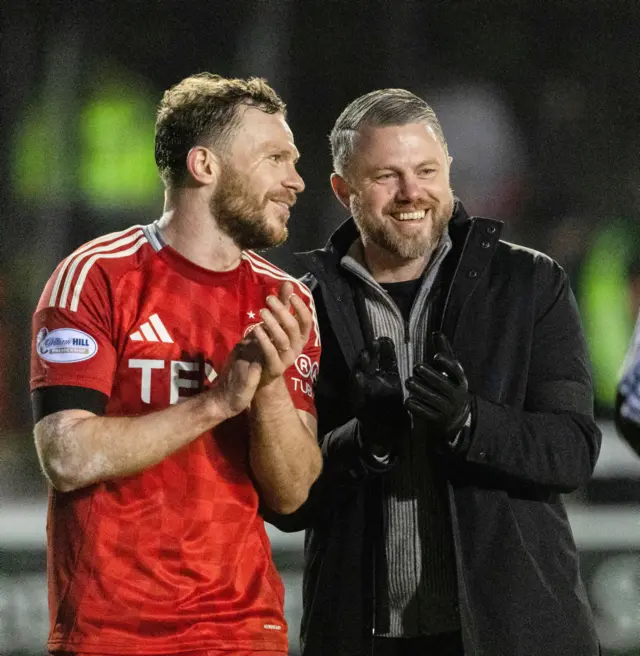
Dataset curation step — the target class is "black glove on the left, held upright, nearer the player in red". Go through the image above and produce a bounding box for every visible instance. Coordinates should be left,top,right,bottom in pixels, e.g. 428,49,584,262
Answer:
353,337,411,455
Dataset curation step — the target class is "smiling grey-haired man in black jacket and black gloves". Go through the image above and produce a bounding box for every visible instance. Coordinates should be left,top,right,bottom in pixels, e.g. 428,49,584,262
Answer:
269,89,601,656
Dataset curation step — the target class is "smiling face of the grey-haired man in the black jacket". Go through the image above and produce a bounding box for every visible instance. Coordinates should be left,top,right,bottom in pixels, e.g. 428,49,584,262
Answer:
332,123,453,263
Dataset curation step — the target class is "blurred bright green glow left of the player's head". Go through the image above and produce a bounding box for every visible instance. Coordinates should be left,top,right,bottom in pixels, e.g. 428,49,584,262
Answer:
11,72,162,209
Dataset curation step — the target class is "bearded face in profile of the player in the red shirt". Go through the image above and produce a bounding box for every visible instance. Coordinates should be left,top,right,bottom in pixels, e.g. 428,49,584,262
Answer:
210,106,304,249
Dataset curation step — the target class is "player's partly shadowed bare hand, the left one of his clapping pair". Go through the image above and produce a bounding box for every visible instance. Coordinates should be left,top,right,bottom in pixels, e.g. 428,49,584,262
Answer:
207,337,262,419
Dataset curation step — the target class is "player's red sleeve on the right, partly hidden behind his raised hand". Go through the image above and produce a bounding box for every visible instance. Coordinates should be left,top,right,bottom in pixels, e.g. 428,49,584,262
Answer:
285,282,321,417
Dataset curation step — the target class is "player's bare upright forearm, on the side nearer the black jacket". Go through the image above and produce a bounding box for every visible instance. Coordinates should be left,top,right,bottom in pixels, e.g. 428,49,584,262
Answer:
249,377,322,513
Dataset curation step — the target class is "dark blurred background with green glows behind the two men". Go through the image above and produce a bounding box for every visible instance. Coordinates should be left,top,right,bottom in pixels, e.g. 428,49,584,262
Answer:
0,0,640,656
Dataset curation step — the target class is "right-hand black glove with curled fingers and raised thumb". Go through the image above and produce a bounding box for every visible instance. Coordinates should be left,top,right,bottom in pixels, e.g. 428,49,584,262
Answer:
405,332,471,444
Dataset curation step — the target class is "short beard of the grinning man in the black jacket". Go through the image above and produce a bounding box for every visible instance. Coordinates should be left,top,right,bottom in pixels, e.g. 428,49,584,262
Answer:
351,194,453,260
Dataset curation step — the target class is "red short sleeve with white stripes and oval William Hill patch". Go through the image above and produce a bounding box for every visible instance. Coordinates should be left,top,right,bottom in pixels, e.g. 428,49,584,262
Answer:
31,262,116,396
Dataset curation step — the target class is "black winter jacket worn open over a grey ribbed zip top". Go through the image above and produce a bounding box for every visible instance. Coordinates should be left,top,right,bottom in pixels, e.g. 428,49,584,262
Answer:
267,203,601,656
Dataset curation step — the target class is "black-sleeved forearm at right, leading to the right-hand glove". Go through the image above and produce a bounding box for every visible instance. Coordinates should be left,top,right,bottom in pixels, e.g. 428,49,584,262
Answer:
464,399,601,492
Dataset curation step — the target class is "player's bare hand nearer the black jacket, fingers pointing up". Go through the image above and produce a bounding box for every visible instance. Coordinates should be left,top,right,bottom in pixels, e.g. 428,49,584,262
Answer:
247,282,313,387
